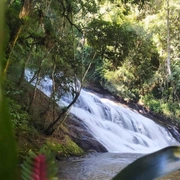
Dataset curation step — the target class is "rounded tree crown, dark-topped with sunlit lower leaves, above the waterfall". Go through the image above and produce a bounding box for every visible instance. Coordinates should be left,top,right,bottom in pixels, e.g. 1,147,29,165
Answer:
88,17,159,101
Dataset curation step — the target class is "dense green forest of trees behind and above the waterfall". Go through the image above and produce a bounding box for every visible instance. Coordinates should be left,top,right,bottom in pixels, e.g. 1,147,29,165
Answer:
0,0,180,179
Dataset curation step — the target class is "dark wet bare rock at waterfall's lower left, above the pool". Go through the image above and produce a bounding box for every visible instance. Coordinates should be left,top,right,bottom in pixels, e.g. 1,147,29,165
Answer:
66,115,107,152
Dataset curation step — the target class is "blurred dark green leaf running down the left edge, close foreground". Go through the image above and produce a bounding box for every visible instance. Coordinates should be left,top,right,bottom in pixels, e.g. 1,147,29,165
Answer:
0,1,18,180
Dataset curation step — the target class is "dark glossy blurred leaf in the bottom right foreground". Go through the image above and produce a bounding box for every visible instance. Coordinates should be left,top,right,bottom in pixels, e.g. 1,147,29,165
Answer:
112,146,180,180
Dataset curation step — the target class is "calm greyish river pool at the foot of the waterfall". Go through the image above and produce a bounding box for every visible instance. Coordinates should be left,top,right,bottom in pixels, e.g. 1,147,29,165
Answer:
58,153,180,180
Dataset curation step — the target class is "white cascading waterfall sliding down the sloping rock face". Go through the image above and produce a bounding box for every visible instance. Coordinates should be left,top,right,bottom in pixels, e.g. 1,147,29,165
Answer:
26,70,178,153
